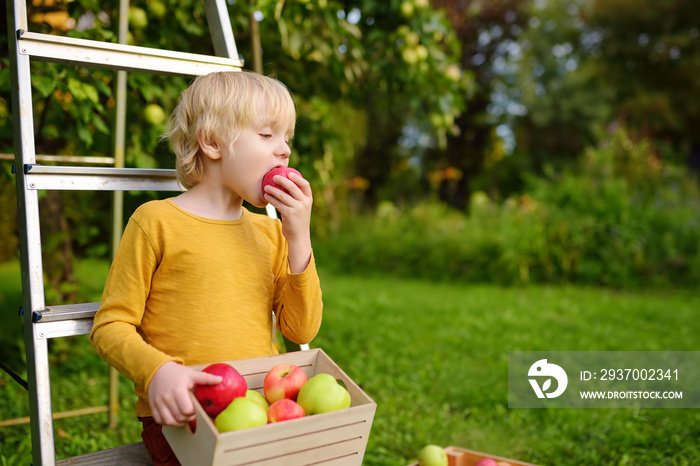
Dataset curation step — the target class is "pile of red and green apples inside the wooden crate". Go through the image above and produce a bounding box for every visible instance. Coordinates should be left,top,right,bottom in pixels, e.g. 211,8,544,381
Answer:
189,363,350,432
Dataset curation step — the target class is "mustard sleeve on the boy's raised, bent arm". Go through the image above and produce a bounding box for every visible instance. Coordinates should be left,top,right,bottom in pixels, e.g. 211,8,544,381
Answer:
274,252,323,344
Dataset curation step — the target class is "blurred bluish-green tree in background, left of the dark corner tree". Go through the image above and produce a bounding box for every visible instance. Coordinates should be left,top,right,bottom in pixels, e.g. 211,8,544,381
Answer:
499,0,615,181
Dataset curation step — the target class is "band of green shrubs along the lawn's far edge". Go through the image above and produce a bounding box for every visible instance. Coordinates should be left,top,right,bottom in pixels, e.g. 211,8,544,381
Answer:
315,130,700,287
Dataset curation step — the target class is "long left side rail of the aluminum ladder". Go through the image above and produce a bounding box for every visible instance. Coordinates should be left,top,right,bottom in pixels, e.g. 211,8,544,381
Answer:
7,0,55,465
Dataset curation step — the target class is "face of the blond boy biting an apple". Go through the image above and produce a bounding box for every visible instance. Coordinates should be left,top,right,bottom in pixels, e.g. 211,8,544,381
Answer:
221,127,291,207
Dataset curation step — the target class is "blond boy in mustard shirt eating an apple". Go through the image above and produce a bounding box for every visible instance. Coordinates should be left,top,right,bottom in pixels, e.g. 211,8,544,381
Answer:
90,72,323,464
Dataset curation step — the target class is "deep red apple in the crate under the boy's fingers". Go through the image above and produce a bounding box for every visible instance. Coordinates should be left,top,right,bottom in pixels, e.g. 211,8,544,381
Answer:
192,362,248,417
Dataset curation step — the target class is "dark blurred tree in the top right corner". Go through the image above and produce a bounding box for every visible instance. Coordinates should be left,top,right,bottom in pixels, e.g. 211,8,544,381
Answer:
588,0,700,164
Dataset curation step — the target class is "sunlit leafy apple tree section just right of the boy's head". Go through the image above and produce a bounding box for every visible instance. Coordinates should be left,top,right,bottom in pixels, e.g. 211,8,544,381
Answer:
249,0,468,207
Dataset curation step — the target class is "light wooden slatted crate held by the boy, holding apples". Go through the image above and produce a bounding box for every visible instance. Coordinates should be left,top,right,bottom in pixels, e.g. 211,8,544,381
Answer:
163,349,377,466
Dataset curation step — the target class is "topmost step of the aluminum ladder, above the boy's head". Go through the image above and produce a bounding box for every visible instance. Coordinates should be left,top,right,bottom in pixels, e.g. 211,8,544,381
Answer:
17,30,243,76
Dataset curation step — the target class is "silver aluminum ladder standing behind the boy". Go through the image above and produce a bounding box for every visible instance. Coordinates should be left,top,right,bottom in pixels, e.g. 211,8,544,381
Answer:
7,0,260,465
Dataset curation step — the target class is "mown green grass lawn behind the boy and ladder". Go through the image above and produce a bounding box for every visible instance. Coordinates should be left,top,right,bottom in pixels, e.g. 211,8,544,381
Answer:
0,260,700,465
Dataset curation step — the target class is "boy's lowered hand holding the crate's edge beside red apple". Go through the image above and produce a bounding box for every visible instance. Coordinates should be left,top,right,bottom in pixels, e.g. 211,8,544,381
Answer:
148,361,221,427
